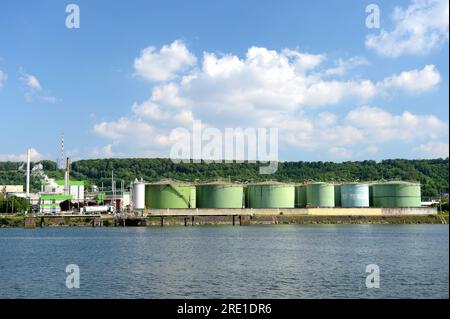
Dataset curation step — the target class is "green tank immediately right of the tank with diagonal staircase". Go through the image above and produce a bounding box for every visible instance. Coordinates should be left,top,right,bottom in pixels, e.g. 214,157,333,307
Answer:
196,183,244,208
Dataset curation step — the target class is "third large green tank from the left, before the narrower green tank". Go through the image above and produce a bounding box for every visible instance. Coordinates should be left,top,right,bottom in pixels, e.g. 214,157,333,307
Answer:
247,183,295,208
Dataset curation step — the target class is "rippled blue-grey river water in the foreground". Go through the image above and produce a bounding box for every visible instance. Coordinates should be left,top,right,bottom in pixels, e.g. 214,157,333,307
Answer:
0,225,449,298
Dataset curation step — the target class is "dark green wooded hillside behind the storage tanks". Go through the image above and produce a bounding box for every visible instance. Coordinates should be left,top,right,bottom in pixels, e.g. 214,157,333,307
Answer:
0,158,449,196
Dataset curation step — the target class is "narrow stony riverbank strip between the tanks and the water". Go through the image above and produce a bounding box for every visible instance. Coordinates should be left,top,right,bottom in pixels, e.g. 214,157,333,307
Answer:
0,214,449,228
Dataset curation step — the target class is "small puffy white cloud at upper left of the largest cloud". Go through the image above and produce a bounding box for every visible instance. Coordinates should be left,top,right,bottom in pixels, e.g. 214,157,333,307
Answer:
134,40,196,82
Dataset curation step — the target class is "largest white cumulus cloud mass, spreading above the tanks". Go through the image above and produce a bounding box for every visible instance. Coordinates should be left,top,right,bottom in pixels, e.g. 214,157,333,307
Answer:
94,41,446,158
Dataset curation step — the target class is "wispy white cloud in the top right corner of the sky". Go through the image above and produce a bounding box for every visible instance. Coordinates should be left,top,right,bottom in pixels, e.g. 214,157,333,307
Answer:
366,0,449,57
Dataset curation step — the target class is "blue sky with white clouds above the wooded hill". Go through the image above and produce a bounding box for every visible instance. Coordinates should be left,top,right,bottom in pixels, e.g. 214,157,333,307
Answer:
0,0,449,161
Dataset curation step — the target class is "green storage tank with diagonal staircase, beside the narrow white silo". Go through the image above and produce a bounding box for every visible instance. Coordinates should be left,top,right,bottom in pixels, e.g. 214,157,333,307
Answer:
145,181,196,208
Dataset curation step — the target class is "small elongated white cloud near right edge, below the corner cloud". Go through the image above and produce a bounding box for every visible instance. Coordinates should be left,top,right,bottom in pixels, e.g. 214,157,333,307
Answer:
381,64,441,93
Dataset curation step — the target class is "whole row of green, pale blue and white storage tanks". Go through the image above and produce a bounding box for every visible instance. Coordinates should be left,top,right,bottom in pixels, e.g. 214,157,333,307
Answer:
132,180,421,209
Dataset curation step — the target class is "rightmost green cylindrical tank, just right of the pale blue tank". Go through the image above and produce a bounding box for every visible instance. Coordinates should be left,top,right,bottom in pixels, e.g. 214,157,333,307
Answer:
373,182,421,207
